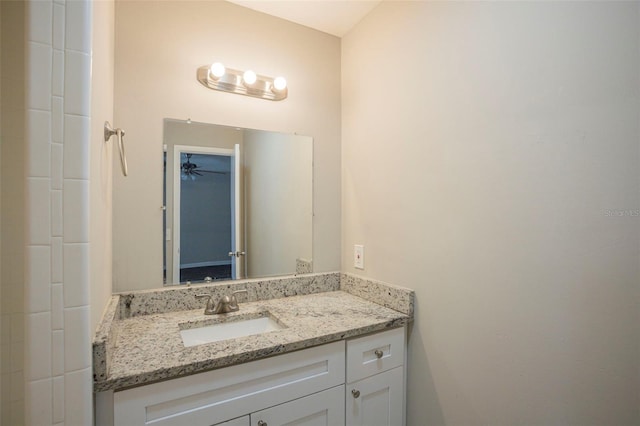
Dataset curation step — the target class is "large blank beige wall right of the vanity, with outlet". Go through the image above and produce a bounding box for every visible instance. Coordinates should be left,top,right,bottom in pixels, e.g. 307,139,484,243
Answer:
342,2,640,425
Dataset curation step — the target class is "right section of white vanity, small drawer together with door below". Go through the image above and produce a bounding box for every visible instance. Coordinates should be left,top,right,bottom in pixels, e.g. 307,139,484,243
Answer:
346,328,405,426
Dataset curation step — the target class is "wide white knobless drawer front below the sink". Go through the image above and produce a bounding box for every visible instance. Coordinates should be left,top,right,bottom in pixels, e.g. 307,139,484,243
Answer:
114,342,345,426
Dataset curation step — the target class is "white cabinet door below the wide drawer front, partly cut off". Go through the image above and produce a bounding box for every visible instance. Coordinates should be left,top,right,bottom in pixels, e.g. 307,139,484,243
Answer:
251,386,344,426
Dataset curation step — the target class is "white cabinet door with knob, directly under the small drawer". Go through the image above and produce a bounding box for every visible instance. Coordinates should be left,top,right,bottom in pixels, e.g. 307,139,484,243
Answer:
346,367,404,426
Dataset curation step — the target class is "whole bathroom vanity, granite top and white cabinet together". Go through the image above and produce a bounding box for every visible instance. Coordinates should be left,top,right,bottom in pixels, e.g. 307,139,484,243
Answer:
94,274,413,426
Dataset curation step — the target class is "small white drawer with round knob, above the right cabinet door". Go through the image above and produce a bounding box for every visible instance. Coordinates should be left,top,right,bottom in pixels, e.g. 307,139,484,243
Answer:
347,328,405,383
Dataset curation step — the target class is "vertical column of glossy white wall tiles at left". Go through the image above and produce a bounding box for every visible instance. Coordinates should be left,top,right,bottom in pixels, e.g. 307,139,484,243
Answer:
21,0,92,425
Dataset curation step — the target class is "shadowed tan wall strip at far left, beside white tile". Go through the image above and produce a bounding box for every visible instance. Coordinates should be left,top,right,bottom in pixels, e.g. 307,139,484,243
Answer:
0,1,25,426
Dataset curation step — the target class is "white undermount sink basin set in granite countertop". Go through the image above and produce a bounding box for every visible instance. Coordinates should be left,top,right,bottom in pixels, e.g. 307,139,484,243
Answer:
180,316,284,347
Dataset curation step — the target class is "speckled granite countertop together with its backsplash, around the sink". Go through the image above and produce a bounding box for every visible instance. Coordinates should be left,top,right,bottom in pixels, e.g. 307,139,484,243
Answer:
93,273,414,391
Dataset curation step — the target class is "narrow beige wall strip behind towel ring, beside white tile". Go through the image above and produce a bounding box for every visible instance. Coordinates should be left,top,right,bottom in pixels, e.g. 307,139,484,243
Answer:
89,1,115,331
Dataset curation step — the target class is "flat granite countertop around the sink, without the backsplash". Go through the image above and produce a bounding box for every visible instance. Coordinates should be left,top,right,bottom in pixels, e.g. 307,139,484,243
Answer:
94,272,413,392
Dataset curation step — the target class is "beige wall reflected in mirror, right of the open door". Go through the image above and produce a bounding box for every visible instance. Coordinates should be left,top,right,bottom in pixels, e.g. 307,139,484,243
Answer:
244,130,313,277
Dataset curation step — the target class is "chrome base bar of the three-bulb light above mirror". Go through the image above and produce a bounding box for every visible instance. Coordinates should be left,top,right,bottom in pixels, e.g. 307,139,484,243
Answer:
197,65,289,101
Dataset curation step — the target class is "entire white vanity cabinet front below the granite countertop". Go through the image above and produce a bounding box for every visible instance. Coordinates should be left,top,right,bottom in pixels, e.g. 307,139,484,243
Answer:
96,328,405,426
